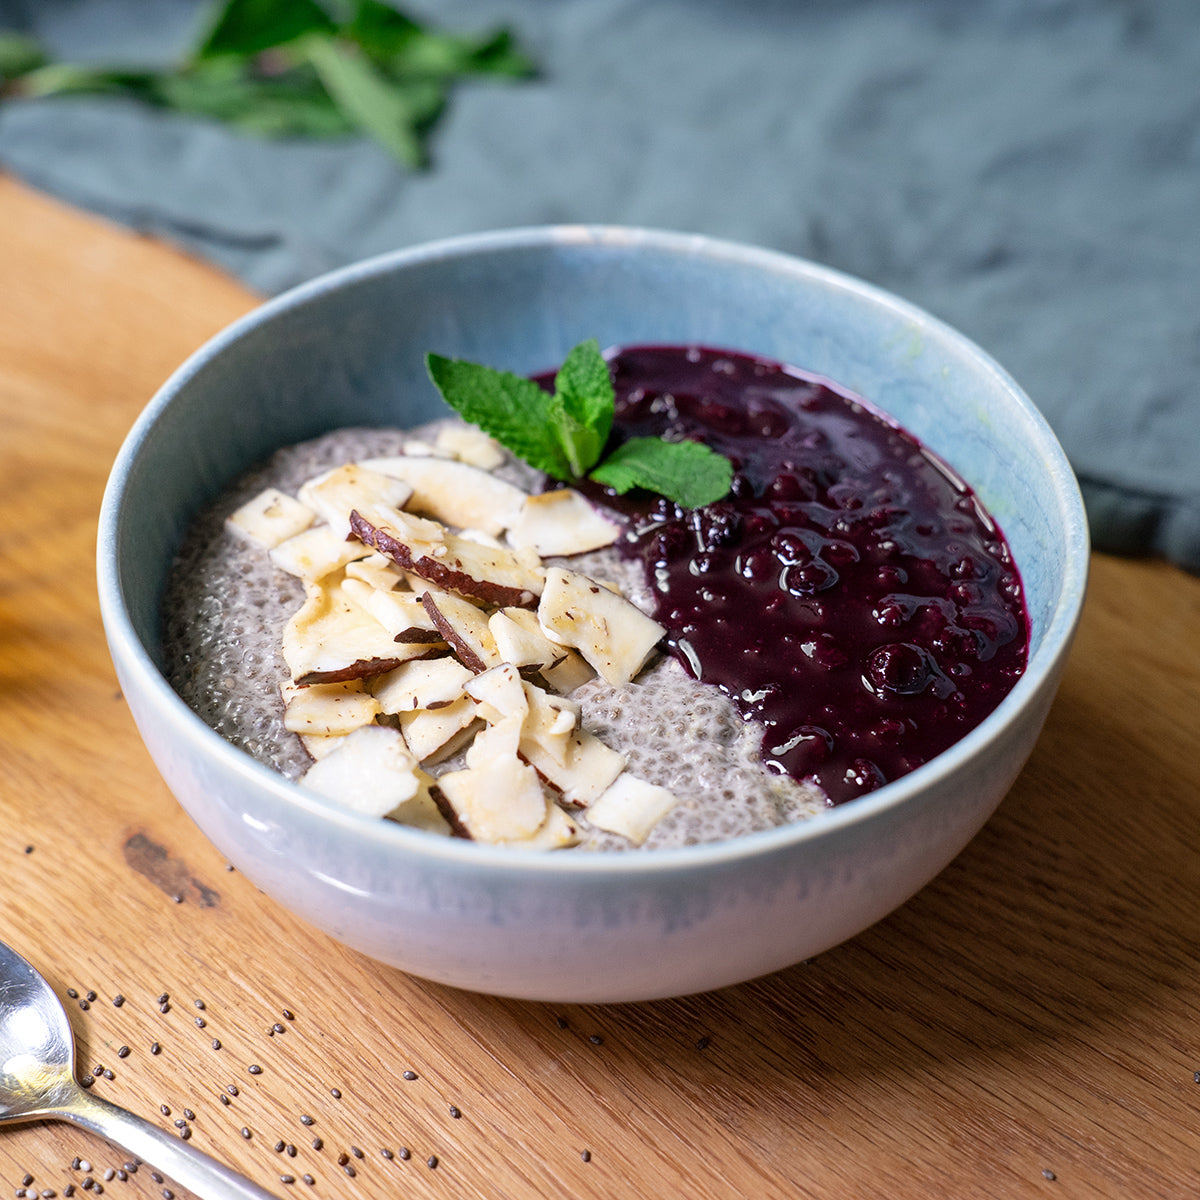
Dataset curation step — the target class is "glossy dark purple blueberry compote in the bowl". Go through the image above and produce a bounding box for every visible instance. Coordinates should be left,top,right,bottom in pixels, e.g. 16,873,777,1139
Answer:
561,347,1028,803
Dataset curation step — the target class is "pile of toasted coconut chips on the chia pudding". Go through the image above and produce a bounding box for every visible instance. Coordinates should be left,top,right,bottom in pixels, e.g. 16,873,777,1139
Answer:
227,428,678,850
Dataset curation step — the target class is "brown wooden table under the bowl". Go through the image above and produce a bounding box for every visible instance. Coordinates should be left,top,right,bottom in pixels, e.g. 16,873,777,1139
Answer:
0,179,1200,1200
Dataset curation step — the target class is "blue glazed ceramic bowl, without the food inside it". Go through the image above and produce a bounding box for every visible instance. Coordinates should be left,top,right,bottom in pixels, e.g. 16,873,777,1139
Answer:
98,227,1088,1002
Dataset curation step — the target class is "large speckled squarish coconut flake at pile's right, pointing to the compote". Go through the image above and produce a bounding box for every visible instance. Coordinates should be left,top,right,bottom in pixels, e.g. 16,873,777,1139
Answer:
538,566,666,688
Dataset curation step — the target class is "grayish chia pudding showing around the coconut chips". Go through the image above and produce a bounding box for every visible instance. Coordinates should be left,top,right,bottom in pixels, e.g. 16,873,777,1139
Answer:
162,418,827,853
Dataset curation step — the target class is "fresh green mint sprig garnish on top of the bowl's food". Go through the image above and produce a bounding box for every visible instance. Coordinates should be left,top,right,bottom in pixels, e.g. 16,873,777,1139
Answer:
426,338,733,509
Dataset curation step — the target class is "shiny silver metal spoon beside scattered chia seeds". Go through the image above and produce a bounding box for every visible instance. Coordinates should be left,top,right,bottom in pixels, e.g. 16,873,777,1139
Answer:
0,942,275,1200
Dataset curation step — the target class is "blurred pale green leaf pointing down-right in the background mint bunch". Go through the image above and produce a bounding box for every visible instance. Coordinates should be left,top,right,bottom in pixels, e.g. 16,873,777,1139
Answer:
304,35,430,167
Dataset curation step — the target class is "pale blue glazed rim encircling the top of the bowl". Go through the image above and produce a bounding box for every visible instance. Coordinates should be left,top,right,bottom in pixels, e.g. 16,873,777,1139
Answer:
96,224,1090,877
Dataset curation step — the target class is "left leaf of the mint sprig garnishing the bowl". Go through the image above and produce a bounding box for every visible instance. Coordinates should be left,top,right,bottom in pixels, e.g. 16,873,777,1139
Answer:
425,354,572,480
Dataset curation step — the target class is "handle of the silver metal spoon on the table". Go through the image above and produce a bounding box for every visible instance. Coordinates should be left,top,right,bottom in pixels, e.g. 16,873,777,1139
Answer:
56,1087,276,1200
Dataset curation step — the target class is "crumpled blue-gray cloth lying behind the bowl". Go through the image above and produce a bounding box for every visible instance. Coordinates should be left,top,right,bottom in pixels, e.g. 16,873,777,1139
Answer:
0,0,1200,570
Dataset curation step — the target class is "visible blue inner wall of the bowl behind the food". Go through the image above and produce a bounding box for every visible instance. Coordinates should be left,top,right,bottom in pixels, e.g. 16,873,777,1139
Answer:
101,227,1086,811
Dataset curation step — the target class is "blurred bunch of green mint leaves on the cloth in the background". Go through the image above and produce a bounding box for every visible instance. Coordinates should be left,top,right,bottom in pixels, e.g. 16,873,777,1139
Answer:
0,0,534,168
